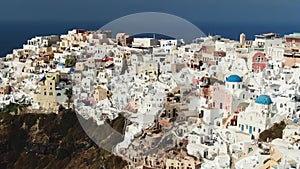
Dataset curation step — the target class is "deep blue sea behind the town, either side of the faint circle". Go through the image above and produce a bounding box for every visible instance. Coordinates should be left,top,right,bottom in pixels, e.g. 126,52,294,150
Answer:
0,21,300,57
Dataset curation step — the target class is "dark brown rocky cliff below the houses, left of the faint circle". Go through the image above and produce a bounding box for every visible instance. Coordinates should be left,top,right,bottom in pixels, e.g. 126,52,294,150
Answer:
0,110,126,169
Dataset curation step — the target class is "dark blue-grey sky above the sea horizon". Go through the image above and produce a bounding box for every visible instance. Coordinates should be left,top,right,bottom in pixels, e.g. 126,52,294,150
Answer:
0,0,300,23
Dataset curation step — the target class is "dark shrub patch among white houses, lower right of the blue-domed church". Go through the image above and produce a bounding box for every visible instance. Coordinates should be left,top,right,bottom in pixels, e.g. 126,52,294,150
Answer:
259,121,286,141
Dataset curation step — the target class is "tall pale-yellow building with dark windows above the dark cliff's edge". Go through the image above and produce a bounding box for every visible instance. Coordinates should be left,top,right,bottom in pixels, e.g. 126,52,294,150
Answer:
35,72,59,110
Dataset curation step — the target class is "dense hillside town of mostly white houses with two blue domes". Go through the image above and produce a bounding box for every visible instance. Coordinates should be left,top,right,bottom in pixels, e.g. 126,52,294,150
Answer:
0,30,300,169
